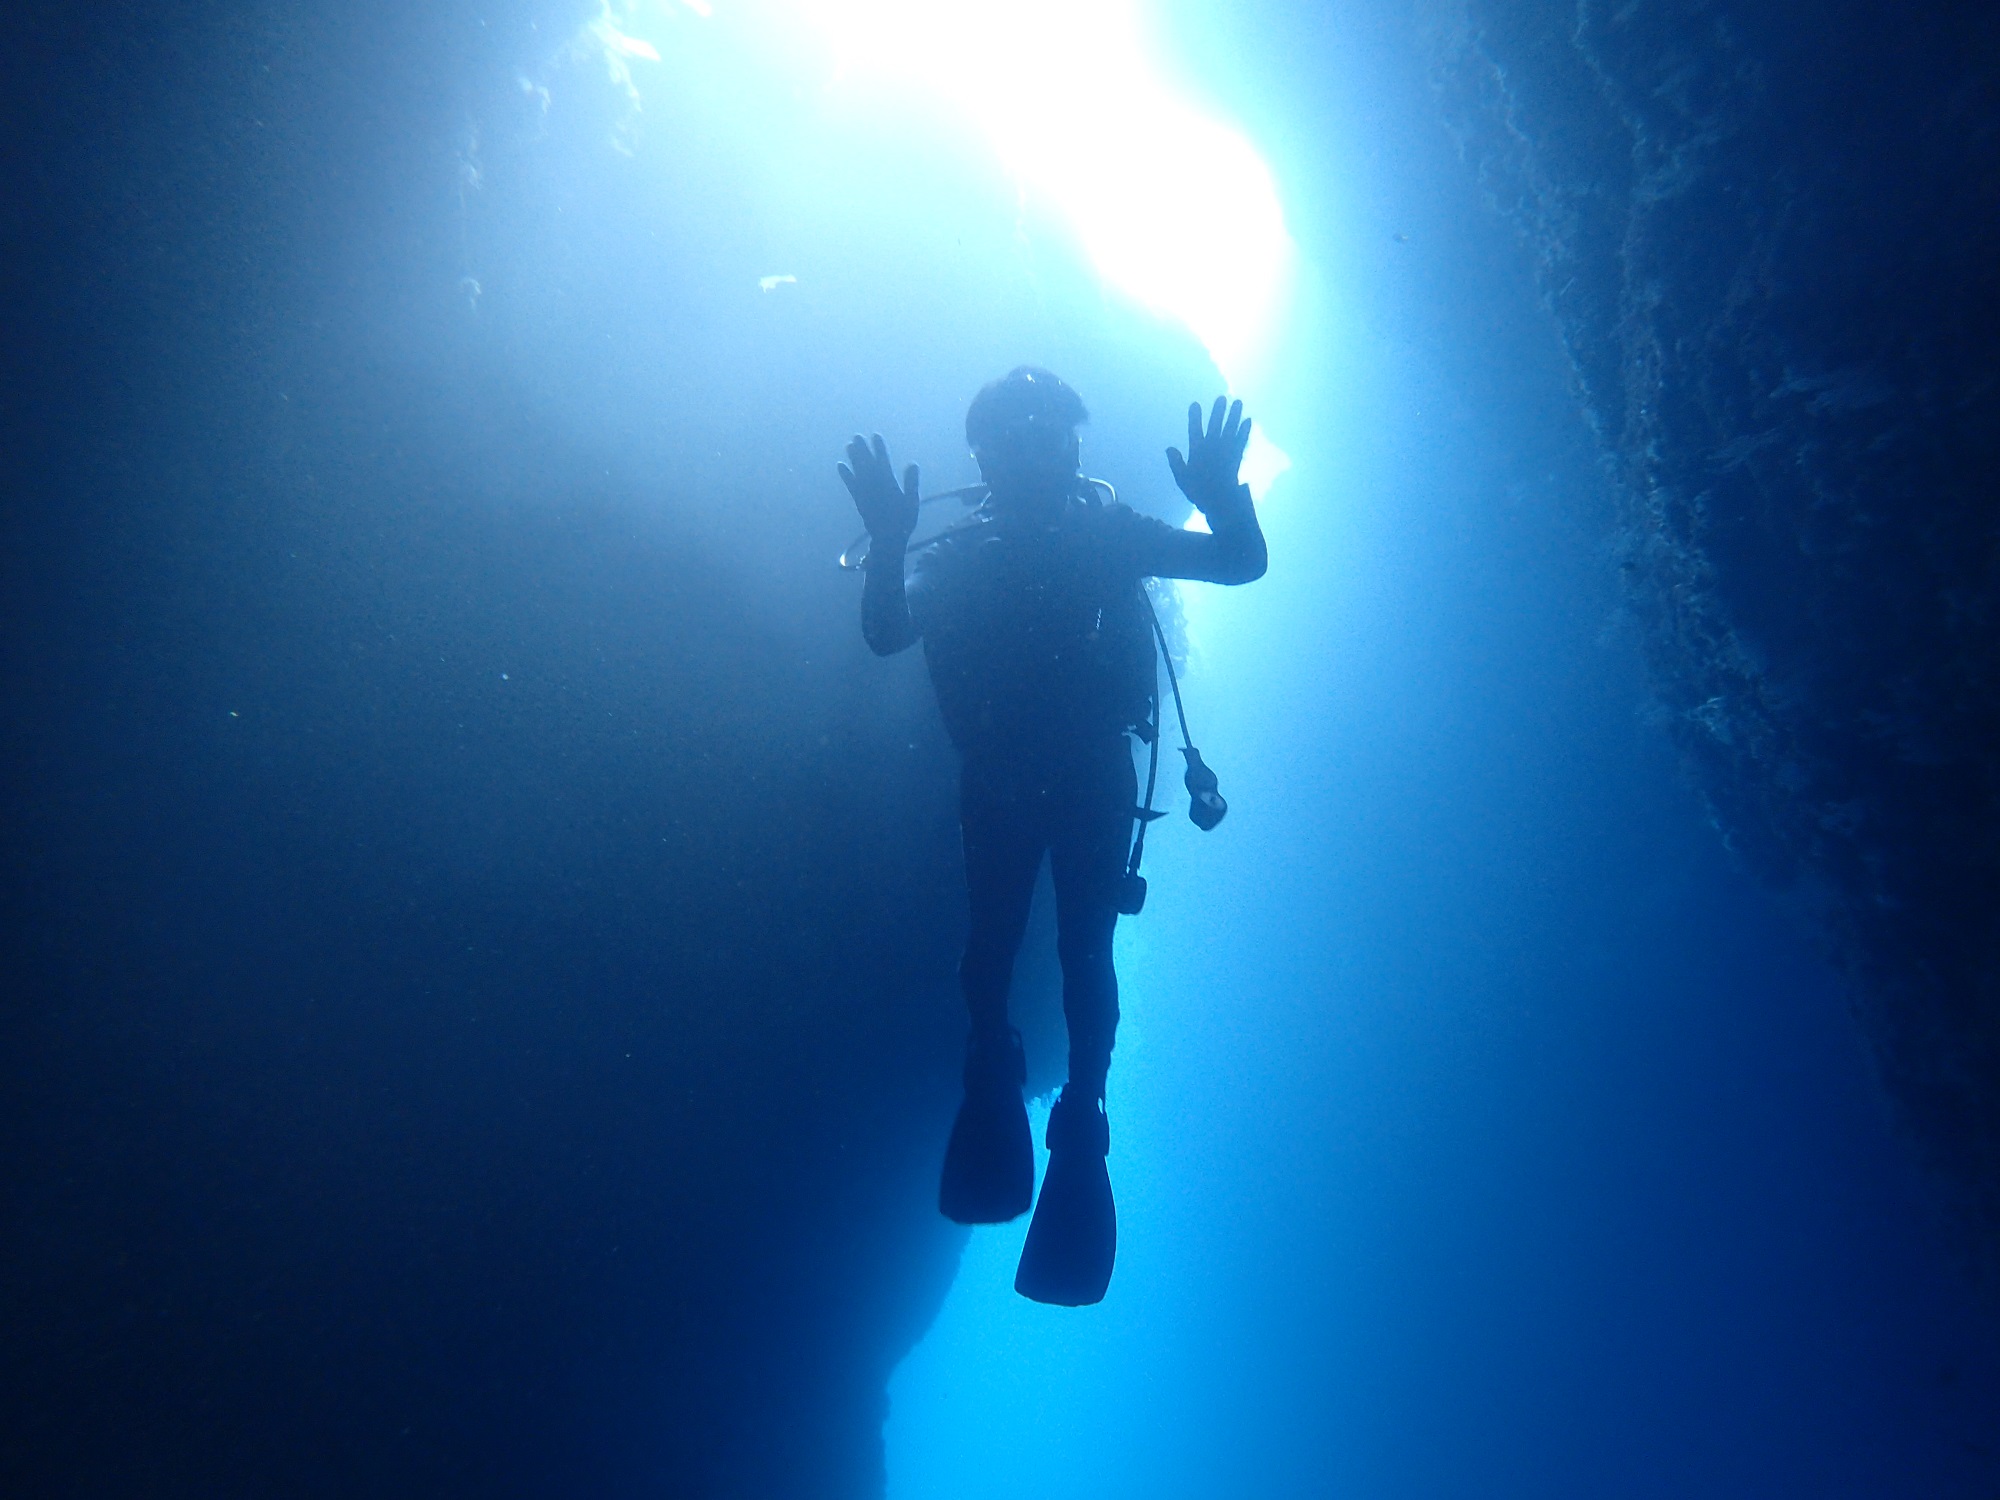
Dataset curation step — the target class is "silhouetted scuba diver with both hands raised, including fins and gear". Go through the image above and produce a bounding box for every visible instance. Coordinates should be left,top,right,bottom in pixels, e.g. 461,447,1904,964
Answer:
838,366,1266,1306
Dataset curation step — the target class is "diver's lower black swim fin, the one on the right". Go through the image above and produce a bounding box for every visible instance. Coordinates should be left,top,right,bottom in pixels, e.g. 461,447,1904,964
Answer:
1014,1090,1118,1308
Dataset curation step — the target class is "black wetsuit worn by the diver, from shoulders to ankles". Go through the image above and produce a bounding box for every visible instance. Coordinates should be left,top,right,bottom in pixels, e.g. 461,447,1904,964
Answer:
908,490,1264,1094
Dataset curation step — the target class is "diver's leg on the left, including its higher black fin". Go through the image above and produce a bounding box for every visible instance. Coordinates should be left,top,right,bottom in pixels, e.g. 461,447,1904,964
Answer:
938,762,1042,1224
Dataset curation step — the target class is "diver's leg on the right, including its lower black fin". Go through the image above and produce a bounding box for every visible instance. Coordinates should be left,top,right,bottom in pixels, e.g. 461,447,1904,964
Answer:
1014,742,1138,1308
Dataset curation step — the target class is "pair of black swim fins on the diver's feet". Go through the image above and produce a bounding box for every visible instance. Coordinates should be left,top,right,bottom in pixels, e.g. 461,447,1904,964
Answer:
938,1028,1118,1308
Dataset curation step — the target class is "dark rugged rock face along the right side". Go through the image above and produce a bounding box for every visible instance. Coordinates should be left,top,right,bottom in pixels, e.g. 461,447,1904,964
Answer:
1434,0,2000,1274
